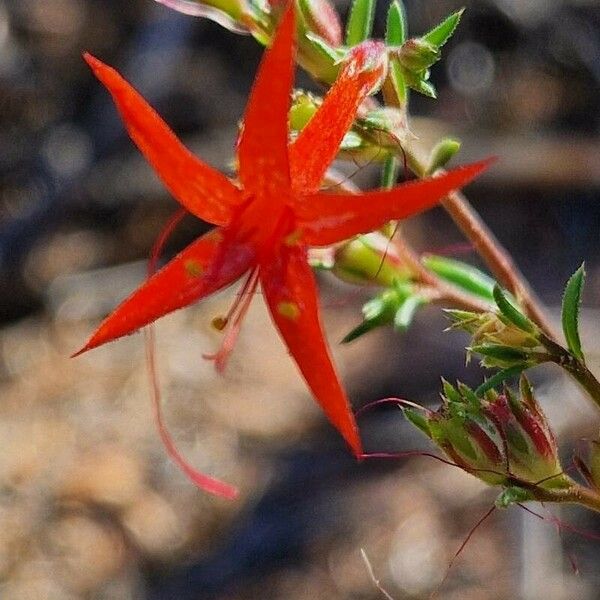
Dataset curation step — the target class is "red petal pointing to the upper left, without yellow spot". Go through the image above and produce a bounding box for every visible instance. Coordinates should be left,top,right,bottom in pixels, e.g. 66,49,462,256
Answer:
83,53,242,225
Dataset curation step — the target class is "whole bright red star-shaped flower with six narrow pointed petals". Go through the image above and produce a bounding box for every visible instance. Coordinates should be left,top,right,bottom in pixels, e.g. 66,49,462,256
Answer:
77,4,487,492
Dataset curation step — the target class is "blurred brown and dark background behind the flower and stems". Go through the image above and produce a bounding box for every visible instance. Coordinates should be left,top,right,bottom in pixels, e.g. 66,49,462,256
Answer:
0,0,600,600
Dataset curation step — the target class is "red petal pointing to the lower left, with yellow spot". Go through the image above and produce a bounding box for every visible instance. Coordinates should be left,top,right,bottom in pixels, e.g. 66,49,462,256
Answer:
74,229,254,356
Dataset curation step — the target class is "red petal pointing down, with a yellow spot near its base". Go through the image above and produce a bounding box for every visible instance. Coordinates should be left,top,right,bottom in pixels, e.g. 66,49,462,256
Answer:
260,246,362,456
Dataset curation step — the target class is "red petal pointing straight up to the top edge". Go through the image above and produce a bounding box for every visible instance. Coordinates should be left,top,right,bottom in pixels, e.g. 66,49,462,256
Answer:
238,2,296,196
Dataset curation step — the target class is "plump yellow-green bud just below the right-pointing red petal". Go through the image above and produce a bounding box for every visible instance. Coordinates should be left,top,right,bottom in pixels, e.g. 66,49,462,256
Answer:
331,232,414,287
